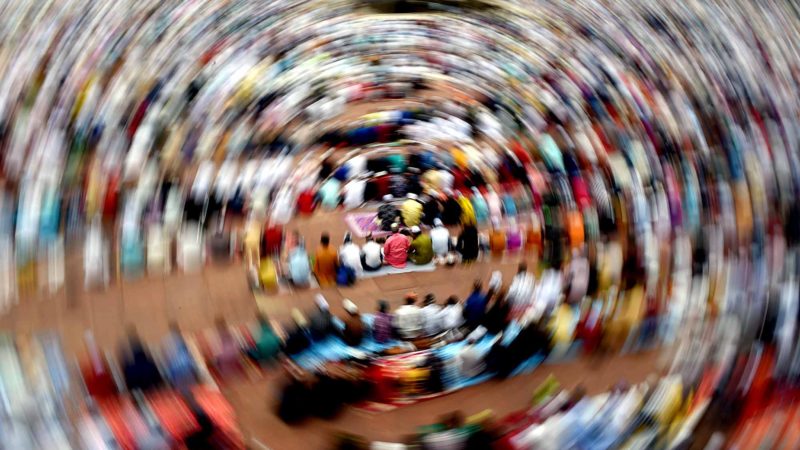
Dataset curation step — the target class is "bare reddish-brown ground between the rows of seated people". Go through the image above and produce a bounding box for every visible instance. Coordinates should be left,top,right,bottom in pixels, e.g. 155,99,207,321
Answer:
0,211,659,450
